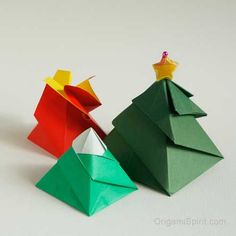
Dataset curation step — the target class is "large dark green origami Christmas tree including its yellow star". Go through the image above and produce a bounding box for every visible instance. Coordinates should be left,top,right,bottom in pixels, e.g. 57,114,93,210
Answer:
105,52,223,195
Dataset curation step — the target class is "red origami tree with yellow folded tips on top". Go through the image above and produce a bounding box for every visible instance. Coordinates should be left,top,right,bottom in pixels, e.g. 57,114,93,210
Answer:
28,70,105,158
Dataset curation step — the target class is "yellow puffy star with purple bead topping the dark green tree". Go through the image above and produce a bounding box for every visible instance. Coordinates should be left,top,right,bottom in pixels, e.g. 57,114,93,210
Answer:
153,51,178,80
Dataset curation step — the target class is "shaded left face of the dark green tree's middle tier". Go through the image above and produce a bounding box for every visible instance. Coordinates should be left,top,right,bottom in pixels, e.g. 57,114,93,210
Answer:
114,104,168,189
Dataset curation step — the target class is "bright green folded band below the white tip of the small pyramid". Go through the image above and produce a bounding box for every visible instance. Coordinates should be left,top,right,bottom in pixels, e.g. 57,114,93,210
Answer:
78,154,137,189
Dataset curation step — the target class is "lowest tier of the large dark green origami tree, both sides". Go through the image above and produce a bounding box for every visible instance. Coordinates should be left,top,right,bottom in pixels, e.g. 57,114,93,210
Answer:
105,130,221,195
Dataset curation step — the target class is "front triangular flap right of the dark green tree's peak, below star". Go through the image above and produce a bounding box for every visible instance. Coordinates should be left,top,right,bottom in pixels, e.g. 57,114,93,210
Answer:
167,81,207,117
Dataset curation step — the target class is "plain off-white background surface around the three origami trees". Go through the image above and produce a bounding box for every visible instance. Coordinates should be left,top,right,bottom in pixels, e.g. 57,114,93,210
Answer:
0,0,236,236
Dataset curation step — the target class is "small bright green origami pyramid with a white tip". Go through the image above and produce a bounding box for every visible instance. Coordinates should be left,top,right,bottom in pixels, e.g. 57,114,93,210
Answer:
36,128,137,216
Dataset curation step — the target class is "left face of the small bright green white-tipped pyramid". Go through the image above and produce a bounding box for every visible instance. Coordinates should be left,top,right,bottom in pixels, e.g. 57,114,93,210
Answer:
36,149,90,214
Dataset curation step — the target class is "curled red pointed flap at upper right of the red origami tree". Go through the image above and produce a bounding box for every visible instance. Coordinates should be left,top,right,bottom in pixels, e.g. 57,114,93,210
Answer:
64,85,101,114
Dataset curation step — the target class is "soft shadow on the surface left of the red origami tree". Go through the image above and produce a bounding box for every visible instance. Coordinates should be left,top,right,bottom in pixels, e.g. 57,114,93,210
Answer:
0,114,51,156
